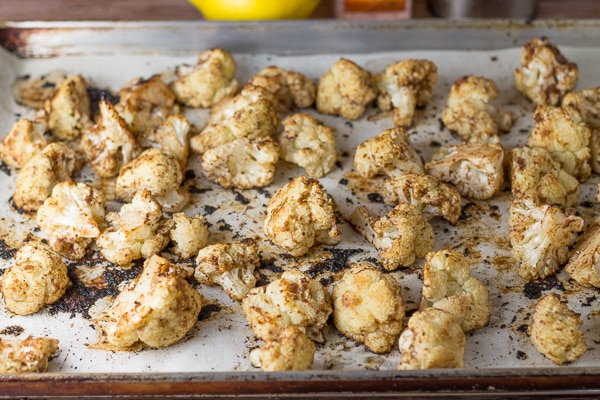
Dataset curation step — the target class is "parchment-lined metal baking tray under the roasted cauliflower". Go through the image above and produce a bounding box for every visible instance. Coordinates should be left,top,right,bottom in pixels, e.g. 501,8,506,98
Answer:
0,20,600,398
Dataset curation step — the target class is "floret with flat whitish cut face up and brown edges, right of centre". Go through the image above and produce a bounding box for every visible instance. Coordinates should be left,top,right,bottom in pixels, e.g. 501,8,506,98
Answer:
425,143,504,200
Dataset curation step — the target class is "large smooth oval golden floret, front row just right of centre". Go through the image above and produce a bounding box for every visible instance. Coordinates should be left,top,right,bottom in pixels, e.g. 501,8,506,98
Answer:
332,262,404,353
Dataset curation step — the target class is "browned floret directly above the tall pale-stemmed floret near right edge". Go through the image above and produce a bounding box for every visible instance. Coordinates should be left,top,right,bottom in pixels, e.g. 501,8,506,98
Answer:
508,146,579,207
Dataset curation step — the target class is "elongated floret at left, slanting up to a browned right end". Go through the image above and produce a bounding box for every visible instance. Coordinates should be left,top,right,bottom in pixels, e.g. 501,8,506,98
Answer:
13,142,80,211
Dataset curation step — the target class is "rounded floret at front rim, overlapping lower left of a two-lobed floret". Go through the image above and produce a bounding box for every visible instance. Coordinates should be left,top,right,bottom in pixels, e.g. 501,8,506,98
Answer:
398,308,466,370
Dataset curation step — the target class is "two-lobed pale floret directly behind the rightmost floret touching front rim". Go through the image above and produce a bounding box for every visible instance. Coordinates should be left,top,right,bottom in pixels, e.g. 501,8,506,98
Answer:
421,250,492,332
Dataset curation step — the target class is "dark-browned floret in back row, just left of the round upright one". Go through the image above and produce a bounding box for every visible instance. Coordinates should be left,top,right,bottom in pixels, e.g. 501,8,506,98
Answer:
248,66,317,112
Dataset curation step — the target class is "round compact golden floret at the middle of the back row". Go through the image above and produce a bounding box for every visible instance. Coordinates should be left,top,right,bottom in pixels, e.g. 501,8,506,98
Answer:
316,58,377,119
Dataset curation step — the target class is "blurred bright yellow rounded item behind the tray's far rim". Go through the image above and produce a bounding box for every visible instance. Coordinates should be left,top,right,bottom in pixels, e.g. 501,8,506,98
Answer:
189,0,319,21
